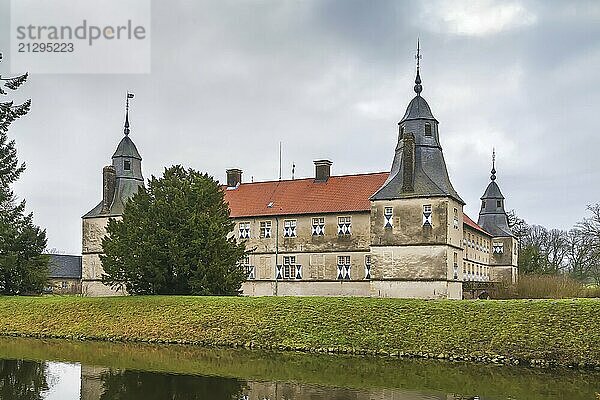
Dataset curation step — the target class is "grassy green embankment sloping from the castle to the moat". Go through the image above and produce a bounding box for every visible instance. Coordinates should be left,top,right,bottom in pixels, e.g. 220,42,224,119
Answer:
0,296,600,368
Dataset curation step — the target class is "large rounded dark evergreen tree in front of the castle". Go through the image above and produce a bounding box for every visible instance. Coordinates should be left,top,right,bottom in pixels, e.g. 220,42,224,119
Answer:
101,165,246,295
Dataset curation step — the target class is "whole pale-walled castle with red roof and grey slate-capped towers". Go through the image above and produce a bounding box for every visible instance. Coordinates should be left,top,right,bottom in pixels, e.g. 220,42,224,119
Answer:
82,58,518,299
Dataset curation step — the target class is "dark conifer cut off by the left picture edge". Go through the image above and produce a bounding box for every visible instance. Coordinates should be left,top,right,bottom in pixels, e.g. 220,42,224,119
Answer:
0,54,48,294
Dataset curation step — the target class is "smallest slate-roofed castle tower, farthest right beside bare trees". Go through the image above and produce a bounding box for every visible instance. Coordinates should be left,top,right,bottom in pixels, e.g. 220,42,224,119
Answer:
477,151,519,283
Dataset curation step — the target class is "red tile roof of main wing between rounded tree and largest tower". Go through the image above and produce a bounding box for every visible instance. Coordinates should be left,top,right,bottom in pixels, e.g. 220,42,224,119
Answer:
225,172,389,218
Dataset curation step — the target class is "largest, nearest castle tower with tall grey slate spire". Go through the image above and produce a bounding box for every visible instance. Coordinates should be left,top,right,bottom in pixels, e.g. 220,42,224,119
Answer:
371,46,464,299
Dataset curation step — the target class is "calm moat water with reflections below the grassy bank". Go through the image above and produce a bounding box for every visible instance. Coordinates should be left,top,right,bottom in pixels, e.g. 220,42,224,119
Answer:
0,338,600,400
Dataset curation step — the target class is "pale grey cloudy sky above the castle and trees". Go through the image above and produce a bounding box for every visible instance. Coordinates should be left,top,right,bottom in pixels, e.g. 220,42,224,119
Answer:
0,0,600,254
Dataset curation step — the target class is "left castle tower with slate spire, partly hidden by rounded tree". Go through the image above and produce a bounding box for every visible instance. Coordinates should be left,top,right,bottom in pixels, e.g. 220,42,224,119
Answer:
81,93,144,296
